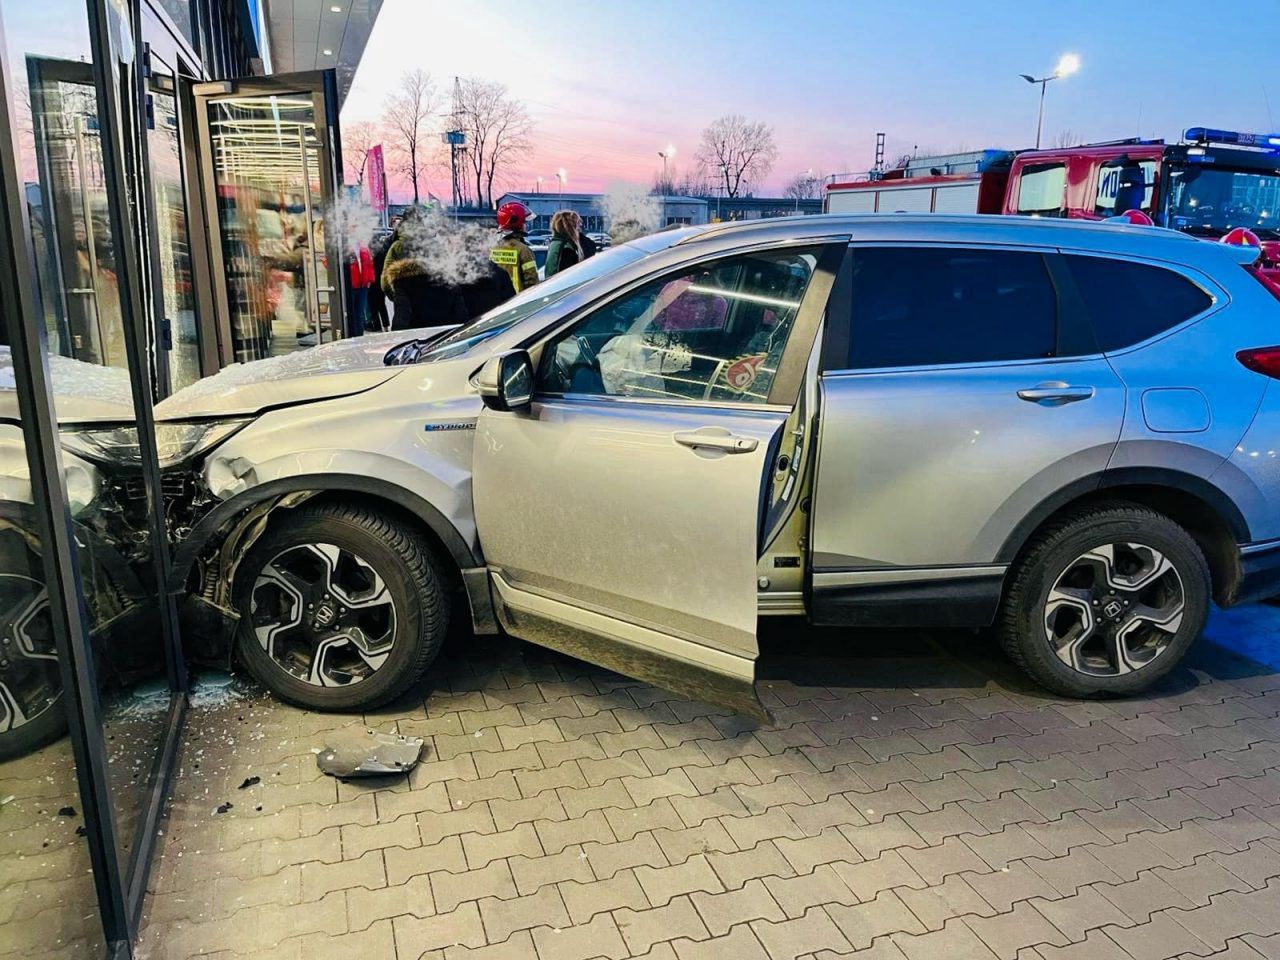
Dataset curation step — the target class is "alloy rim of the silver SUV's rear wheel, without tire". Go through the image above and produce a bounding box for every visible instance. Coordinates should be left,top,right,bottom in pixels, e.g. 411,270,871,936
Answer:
1044,543,1187,676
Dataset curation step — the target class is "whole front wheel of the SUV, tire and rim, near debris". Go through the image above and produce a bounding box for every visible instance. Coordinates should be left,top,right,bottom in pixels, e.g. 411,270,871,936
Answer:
236,504,449,710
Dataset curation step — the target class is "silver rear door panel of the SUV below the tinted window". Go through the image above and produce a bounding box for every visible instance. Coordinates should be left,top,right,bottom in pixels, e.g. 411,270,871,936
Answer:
813,358,1124,572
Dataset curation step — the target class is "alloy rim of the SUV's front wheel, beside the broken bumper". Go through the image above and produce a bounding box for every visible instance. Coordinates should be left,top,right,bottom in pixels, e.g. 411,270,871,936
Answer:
250,543,397,687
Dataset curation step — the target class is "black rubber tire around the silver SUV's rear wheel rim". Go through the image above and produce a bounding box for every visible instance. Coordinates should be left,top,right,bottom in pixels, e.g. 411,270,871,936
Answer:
997,502,1211,699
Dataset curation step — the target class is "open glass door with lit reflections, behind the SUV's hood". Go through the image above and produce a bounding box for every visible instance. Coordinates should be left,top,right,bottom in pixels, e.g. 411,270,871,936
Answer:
195,70,344,361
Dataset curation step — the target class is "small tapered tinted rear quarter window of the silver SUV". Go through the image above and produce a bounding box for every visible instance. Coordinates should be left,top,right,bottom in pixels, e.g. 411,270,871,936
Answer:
1064,255,1213,351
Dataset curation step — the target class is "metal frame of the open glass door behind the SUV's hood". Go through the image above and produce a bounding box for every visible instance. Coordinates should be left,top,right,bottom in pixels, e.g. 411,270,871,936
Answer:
189,69,348,364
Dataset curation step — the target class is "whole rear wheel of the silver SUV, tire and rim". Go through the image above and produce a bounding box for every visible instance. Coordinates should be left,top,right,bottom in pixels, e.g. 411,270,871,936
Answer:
1000,503,1211,698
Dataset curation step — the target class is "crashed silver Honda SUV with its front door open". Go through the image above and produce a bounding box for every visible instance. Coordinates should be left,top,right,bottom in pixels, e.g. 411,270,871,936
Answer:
2,215,1280,742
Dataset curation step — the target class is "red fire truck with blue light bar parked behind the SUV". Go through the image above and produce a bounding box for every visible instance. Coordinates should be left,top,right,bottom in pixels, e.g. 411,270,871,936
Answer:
826,127,1280,282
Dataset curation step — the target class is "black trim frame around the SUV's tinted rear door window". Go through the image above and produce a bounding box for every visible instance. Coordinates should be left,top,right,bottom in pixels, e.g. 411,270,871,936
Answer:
818,239,1102,376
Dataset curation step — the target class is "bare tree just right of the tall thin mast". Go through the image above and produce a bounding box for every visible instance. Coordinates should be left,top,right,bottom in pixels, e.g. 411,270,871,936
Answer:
453,77,534,207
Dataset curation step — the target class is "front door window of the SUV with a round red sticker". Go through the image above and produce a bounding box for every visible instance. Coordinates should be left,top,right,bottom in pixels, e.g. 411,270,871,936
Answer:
539,248,818,403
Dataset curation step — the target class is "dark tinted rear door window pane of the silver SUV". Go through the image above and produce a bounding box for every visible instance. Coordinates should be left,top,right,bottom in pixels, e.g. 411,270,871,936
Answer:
849,247,1057,369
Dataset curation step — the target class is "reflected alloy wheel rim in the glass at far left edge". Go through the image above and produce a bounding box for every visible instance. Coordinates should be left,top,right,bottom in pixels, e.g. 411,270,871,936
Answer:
0,573,61,733
